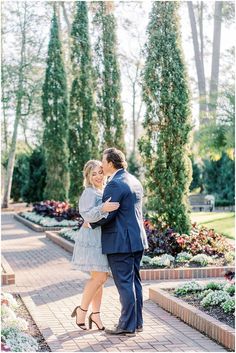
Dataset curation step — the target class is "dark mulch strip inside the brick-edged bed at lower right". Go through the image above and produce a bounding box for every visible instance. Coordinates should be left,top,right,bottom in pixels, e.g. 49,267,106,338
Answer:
165,289,235,328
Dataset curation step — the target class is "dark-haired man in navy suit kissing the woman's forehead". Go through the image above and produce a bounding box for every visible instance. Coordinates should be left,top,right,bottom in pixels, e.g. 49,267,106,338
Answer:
91,148,148,336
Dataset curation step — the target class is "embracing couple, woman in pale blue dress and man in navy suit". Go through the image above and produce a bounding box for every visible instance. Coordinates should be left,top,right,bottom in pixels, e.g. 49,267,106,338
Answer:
72,148,147,336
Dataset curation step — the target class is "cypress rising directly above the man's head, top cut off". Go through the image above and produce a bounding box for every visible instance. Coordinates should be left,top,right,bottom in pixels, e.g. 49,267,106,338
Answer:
93,1,125,151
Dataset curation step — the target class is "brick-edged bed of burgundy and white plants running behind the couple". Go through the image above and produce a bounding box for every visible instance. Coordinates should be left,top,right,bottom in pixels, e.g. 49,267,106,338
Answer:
47,212,235,280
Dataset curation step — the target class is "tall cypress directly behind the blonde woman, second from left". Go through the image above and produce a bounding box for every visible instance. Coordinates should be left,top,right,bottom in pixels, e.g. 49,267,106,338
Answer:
69,1,98,203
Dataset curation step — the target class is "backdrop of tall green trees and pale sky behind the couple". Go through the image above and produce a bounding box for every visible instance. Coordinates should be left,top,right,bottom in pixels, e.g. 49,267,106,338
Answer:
1,1,235,227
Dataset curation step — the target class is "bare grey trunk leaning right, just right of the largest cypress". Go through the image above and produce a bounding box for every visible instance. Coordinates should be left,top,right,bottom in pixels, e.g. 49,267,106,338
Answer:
187,1,208,124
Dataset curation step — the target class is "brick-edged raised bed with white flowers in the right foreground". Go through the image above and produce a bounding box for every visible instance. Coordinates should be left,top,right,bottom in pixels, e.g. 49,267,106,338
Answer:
149,280,235,351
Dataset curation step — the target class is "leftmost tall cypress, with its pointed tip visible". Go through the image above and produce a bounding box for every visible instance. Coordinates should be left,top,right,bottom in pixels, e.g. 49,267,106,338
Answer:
42,7,69,200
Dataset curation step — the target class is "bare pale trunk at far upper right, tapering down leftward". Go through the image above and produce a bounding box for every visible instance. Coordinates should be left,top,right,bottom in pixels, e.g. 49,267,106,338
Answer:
209,1,223,117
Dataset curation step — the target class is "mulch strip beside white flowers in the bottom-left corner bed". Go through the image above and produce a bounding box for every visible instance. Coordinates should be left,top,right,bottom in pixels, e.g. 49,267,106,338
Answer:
13,294,51,352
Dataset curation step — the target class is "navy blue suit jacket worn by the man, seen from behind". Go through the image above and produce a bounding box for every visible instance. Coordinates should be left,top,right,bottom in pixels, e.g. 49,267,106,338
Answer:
91,169,148,254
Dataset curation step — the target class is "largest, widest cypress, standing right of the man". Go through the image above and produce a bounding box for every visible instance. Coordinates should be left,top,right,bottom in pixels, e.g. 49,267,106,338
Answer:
139,1,191,232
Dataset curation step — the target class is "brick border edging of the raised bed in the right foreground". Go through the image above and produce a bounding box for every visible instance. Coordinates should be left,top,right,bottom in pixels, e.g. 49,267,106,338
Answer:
149,282,235,351
